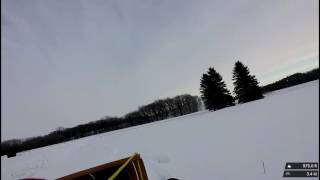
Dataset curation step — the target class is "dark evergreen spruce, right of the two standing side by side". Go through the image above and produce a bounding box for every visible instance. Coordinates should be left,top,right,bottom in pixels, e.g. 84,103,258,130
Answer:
232,61,263,103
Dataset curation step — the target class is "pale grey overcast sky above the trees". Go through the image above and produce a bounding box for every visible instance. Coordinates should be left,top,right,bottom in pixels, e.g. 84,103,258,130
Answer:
1,0,319,140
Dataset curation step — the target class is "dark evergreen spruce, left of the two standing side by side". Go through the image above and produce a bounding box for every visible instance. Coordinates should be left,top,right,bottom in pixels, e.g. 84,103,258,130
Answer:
200,67,234,110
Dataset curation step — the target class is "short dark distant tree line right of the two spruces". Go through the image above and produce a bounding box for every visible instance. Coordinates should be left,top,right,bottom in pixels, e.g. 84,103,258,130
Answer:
262,68,319,93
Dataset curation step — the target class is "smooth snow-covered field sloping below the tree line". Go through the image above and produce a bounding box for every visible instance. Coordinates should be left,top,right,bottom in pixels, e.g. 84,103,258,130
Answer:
1,80,319,180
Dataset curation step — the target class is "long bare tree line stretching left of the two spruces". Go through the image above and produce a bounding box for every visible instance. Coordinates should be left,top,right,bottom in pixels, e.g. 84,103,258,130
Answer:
1,94,202,157
